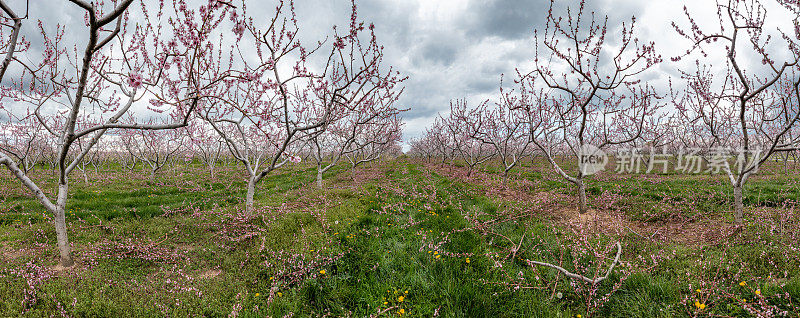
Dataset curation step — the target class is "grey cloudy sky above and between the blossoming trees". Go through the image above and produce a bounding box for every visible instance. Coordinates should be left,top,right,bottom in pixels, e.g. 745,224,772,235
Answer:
6,0,791,148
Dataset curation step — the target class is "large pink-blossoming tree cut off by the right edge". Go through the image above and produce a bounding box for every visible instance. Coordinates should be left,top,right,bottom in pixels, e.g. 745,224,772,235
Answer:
673,0,800,224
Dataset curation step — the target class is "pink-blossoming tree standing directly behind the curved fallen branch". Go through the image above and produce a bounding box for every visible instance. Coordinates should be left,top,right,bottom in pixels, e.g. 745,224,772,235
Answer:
507,1,661,213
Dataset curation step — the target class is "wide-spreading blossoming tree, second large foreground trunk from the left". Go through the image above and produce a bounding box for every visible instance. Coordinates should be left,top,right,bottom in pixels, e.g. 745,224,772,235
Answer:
200,1,404,212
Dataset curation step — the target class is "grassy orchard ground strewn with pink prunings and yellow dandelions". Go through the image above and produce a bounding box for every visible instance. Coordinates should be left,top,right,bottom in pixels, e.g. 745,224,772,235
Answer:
0,156,800,317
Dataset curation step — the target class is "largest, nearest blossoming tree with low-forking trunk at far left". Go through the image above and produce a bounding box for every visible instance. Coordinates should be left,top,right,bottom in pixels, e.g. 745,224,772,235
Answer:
0,0,232,267
